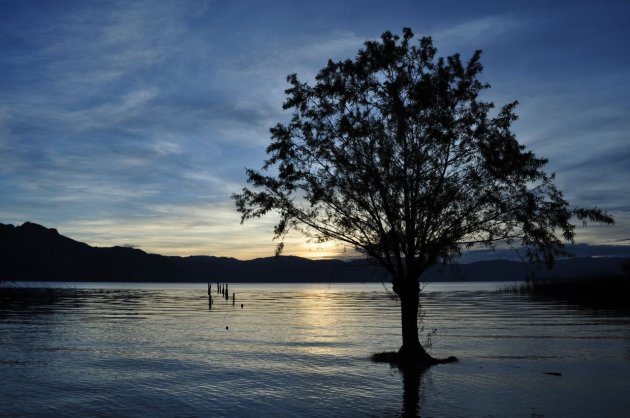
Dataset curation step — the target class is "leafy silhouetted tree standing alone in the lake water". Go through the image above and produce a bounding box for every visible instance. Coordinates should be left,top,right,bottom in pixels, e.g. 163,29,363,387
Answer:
233,28,613,362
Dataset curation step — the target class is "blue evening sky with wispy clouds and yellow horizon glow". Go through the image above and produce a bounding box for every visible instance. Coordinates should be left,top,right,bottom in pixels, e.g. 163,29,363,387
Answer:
0,0,630,259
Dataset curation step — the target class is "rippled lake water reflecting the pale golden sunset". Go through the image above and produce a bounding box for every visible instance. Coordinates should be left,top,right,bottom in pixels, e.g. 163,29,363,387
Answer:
0,283,630,417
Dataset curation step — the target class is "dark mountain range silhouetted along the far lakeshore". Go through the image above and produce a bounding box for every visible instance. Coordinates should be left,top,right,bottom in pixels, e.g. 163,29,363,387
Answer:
0,222,624,283
